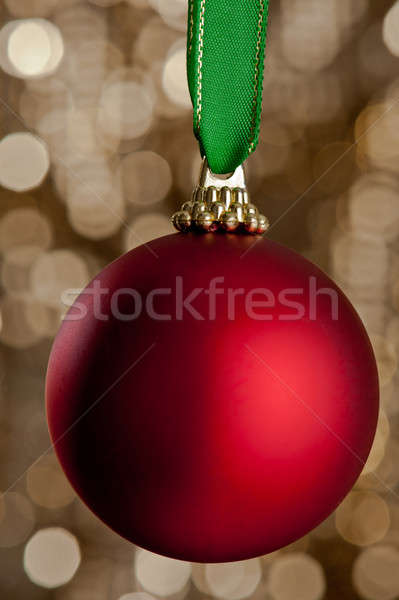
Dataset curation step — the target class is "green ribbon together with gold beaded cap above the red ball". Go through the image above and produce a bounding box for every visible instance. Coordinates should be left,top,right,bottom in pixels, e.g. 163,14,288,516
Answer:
172,0,269,235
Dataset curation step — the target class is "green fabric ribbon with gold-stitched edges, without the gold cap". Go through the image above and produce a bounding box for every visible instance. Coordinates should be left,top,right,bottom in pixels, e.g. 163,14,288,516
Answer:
187,0,269,174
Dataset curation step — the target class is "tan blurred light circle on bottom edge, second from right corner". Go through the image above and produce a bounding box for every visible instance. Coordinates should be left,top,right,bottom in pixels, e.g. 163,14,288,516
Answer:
268,552,326,600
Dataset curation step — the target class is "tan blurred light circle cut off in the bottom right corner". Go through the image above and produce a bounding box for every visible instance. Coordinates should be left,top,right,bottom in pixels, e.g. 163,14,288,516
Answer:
352,545,399,600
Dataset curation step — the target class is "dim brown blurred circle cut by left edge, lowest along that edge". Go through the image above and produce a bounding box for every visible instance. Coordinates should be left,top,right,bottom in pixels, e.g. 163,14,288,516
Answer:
0,492,35,548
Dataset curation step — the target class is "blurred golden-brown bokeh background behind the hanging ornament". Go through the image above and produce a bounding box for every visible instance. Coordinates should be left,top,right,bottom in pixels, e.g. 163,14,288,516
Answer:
0,0,399,600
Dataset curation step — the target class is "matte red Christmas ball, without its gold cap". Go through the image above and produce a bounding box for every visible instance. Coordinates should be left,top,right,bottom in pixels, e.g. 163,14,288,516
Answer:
47,234,378,562
